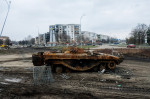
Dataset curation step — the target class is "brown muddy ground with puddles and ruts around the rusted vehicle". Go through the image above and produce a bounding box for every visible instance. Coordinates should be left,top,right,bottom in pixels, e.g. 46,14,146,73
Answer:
0,47,150,99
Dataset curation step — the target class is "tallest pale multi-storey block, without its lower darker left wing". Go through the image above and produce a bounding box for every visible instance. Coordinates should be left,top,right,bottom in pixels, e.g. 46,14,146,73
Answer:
49,24,80,46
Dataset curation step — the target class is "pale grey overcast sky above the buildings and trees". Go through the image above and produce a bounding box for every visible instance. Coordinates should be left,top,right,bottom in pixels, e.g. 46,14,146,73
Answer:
0,0,150,40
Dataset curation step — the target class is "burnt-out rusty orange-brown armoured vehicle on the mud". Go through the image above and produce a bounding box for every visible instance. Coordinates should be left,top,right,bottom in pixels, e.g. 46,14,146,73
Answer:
32,47,123,73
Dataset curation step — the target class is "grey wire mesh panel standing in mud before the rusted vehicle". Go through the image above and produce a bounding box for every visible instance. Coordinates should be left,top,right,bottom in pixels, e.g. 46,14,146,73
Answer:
33,66,54,85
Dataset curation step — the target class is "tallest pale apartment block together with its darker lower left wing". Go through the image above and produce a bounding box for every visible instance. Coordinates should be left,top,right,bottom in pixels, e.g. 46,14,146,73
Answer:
35,24,80,46
